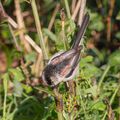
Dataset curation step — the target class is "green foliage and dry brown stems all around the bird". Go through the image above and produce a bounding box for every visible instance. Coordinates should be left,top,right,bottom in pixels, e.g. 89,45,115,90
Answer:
0,0,120,120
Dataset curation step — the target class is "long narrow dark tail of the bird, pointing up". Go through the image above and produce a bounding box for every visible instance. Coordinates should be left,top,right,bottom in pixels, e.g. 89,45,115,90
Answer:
72,13,90,48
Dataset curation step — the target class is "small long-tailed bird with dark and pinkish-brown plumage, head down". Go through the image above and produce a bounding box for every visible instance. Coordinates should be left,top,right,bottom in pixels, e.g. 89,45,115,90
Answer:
42,13,90,88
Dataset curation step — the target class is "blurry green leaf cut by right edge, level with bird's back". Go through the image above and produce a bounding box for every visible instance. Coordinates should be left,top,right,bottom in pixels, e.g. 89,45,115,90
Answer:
108,50,120,66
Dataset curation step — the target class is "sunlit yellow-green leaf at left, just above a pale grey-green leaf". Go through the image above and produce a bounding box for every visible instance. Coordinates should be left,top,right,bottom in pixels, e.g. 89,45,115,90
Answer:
8,68,24,81
